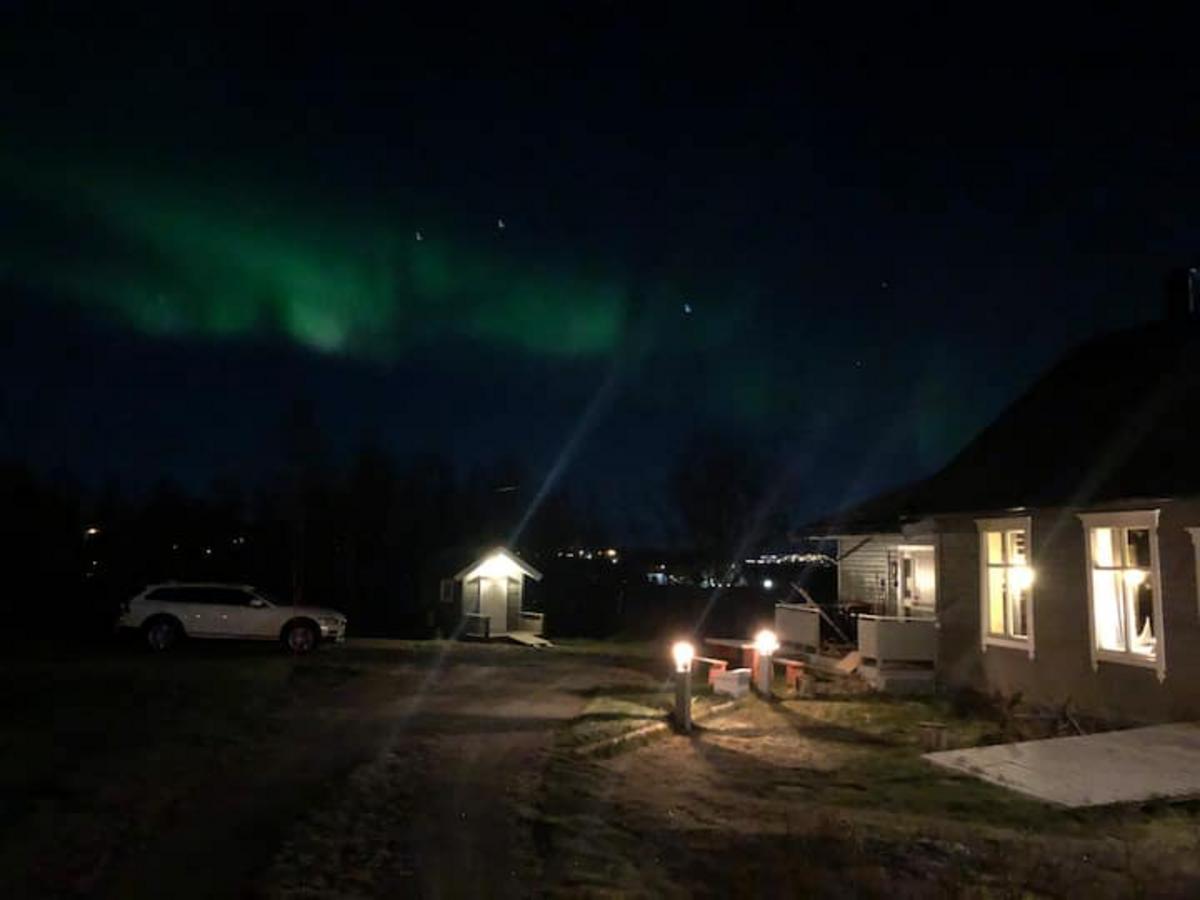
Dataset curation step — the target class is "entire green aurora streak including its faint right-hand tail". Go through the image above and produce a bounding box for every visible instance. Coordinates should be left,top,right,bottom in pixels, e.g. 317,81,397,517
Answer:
0,156,984,465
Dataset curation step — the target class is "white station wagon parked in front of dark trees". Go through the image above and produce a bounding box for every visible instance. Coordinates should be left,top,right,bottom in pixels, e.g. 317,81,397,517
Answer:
118,582,346,653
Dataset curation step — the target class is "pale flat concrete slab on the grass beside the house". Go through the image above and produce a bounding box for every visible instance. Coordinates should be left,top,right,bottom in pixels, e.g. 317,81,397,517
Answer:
924,722,1200,808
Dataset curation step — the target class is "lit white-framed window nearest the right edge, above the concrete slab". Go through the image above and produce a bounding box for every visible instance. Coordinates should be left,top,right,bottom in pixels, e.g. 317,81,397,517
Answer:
1080,510,1165,677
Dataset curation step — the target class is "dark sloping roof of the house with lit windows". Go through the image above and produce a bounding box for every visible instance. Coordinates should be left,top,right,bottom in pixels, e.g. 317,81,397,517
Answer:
809,320,1200,533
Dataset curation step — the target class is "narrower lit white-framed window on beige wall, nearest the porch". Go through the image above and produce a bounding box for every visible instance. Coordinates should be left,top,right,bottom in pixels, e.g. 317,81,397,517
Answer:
977,517,1033,656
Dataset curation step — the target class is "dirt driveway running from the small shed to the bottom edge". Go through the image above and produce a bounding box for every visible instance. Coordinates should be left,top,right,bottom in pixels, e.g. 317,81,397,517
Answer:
264,648,638,896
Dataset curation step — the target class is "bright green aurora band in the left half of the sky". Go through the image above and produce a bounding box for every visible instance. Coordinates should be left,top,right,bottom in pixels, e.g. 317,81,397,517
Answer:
11,162,625,360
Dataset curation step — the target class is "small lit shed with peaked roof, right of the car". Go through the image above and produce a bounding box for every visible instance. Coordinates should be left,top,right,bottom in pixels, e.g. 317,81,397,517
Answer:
443,547,542,637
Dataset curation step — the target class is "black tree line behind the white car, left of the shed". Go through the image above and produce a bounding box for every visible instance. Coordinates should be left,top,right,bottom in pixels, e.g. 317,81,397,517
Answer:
0,444,602,636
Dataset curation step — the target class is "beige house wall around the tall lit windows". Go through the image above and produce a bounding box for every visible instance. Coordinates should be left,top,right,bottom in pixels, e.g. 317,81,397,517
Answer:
937,498,1200,721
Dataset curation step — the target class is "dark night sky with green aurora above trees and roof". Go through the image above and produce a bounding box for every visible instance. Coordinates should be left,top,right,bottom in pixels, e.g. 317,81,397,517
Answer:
0,5,1200,539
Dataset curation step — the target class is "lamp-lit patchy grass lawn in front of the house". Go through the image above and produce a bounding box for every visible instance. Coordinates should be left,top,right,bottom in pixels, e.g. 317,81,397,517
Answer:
535,681,1200,896
